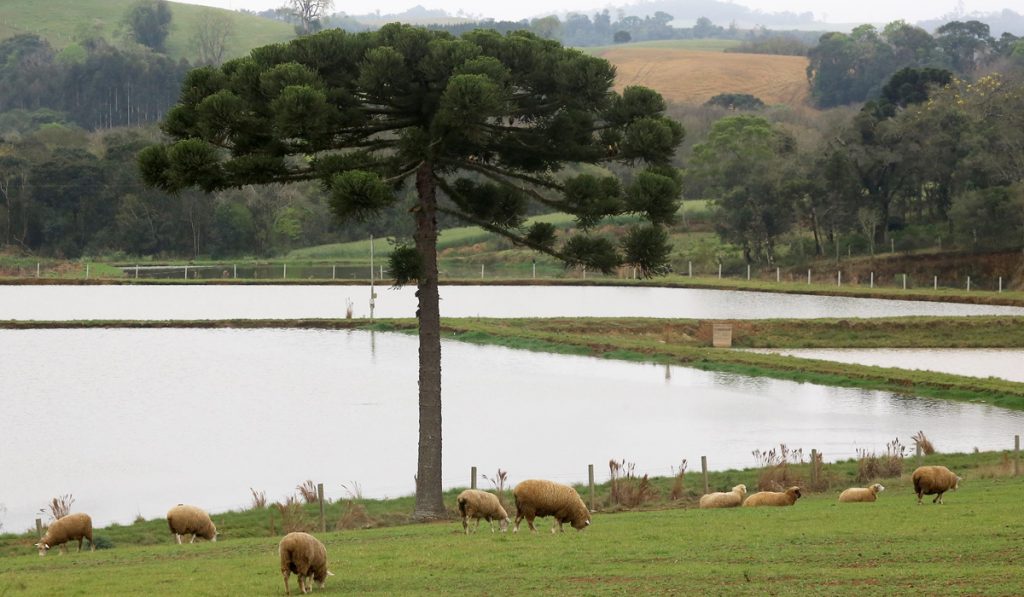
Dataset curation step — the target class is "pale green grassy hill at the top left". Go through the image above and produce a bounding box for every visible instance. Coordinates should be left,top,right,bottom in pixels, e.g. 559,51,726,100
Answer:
0,0,295,61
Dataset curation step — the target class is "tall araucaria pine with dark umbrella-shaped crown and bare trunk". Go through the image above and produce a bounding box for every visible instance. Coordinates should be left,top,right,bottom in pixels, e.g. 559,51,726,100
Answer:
139,25,683,519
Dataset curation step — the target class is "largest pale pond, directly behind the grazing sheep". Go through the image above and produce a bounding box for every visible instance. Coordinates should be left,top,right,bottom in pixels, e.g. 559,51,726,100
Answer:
0,329,1024,531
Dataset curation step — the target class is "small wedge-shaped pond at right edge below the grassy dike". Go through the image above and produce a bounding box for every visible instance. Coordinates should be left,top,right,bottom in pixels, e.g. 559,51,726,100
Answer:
752,348,1024,383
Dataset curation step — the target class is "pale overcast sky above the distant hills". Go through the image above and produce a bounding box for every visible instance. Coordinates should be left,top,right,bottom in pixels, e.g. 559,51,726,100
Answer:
175,0,1024,23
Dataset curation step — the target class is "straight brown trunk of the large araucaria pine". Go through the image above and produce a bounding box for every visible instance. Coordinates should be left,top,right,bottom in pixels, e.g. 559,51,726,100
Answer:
413,163,446,520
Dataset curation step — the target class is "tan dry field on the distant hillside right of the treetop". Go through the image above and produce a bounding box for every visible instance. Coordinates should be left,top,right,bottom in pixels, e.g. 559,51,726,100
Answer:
600,47,809,105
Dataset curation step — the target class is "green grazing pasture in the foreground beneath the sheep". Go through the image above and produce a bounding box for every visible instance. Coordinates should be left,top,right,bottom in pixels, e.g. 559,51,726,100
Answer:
0,453,1024,595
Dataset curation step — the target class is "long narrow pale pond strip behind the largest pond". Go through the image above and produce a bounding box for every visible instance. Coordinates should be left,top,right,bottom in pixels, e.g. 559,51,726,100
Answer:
0,285,1024,321
